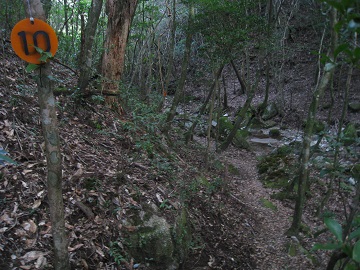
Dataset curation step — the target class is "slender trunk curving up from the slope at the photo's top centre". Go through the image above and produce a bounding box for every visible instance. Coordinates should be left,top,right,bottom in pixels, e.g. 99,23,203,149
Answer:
162,3,195,134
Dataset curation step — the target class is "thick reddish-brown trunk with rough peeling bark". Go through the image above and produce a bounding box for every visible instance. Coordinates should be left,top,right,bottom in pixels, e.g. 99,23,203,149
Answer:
101,0,138,109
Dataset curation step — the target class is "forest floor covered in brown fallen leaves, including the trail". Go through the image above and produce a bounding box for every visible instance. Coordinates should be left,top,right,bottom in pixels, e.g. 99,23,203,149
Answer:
0,19,360,270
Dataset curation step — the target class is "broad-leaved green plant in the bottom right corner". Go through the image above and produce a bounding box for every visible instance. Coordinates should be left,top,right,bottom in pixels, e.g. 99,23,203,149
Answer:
312,215,360,270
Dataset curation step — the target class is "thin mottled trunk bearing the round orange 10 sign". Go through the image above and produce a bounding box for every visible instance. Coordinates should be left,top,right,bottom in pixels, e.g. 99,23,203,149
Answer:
24,0,70,270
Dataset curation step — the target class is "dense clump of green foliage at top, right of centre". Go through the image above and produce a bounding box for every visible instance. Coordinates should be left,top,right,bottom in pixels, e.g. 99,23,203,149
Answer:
192,0,265,61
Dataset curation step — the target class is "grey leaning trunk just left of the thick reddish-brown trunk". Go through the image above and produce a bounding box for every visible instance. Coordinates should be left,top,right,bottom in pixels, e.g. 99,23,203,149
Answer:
78,0,103,93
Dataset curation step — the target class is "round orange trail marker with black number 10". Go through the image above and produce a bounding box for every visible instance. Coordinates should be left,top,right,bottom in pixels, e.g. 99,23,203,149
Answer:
11,18,58,64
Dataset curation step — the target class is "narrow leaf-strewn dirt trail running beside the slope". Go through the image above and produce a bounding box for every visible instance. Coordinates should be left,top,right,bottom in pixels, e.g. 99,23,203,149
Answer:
222,147,314,270
